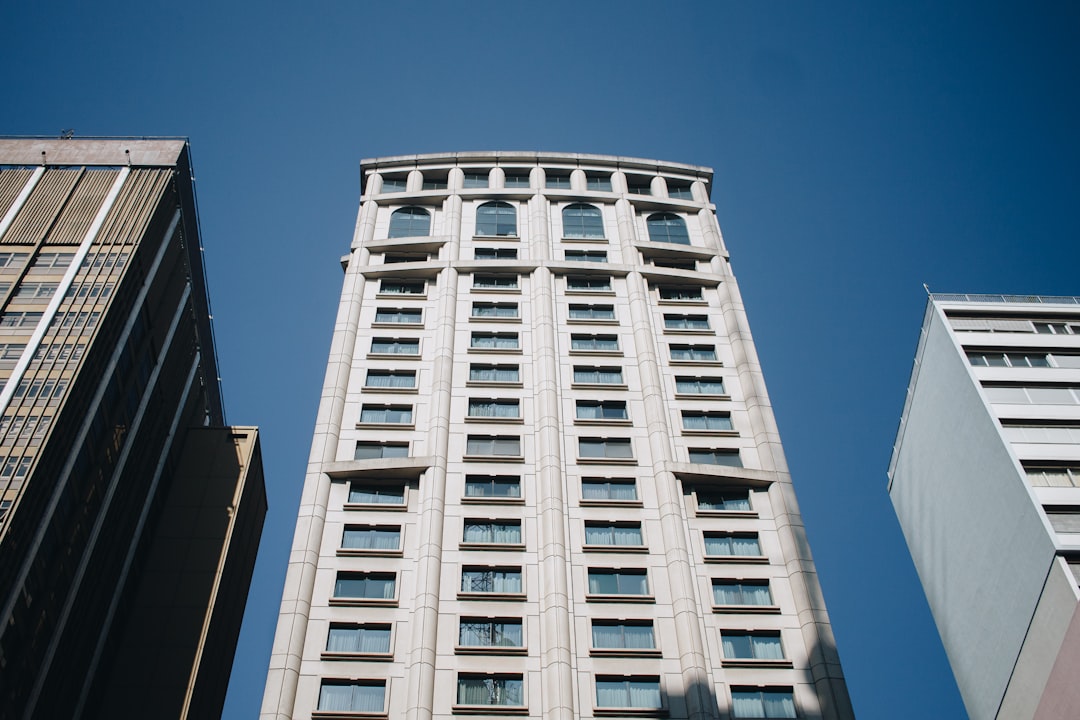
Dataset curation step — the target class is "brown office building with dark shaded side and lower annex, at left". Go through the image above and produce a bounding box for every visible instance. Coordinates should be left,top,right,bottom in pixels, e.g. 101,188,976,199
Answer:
0,138,266,720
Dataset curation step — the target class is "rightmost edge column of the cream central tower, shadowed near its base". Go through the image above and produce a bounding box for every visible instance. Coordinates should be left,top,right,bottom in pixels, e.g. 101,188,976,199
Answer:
699,209,854,720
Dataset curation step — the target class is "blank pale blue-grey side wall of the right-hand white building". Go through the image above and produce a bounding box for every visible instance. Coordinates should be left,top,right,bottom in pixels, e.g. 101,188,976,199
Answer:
890,310,1054,720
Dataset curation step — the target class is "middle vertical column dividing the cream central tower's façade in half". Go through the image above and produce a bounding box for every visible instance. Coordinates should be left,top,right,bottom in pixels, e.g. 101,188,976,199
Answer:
528,187,577,720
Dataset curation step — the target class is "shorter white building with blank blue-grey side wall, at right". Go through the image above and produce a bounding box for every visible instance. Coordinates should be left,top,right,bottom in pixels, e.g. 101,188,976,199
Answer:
889,294,1080,720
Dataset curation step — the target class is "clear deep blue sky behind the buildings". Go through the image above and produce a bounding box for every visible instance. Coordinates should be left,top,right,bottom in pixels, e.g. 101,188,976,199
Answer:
0,0,1080,720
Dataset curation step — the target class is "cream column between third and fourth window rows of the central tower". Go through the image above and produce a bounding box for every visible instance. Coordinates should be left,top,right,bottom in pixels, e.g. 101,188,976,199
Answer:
616,197,718,720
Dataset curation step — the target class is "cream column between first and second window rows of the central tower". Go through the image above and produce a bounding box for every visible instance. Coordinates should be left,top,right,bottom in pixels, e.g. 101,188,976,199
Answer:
405,194,461,720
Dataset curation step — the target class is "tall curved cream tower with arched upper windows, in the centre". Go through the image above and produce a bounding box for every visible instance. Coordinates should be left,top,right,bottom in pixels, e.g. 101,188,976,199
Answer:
262,152,852,720
